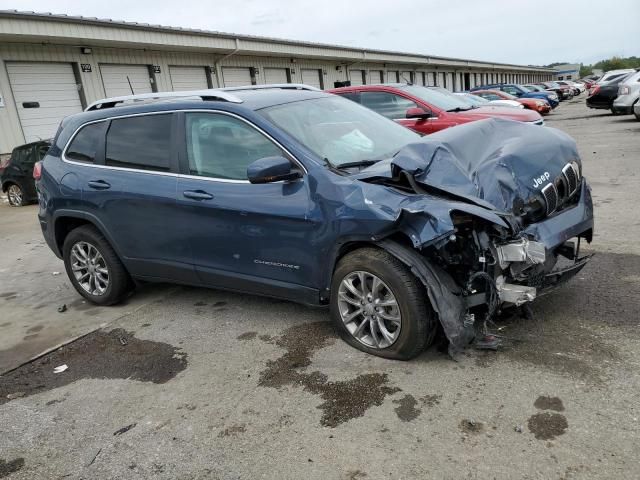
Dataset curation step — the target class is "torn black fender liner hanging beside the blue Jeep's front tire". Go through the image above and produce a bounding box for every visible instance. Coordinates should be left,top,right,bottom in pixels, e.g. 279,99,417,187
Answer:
376,240,476,353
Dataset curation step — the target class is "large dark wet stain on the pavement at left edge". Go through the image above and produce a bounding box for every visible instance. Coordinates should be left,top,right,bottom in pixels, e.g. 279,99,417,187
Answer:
0,328,187,405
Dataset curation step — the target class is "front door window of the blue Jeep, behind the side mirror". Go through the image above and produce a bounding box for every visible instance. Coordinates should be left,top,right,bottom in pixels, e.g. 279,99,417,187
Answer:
185,113,283,180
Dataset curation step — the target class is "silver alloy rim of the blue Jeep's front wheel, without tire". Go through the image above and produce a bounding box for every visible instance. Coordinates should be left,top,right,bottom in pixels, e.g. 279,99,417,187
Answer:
338,271,402,349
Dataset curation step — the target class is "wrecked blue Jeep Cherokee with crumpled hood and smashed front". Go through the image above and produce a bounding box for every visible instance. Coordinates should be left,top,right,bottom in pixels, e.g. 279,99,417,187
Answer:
35,86,593,359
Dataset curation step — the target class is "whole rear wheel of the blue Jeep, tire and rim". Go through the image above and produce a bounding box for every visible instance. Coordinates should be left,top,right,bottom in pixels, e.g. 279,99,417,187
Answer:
62,225,132,305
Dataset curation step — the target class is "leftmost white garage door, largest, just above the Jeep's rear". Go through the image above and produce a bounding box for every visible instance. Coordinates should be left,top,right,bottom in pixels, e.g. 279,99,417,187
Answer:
6,62,82,143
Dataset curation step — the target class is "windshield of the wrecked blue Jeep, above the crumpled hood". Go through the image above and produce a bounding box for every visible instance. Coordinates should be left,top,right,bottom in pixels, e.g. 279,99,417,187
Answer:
258,96,420,167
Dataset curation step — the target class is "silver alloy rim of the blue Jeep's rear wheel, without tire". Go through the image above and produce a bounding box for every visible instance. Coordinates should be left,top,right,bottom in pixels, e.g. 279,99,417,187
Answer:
70,242,109,296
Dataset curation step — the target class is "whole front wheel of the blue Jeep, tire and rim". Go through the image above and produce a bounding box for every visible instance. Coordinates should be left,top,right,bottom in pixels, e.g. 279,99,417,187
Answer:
330,248,437,360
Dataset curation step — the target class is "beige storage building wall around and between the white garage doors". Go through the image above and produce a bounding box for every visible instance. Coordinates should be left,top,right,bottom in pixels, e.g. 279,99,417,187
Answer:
0,42,552,154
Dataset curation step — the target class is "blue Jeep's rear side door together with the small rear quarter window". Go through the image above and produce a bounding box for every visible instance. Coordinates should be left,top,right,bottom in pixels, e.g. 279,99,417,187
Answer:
64,113,197,283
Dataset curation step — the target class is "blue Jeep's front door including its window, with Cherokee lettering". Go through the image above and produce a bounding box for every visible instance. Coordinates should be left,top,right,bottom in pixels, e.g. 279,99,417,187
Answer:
177,112,318,301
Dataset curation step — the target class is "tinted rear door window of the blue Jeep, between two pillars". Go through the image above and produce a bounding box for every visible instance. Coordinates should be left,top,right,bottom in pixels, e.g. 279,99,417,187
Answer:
105,113,172,172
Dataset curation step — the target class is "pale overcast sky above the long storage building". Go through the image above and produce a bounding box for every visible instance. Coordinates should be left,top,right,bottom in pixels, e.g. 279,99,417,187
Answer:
0,0,640,65
